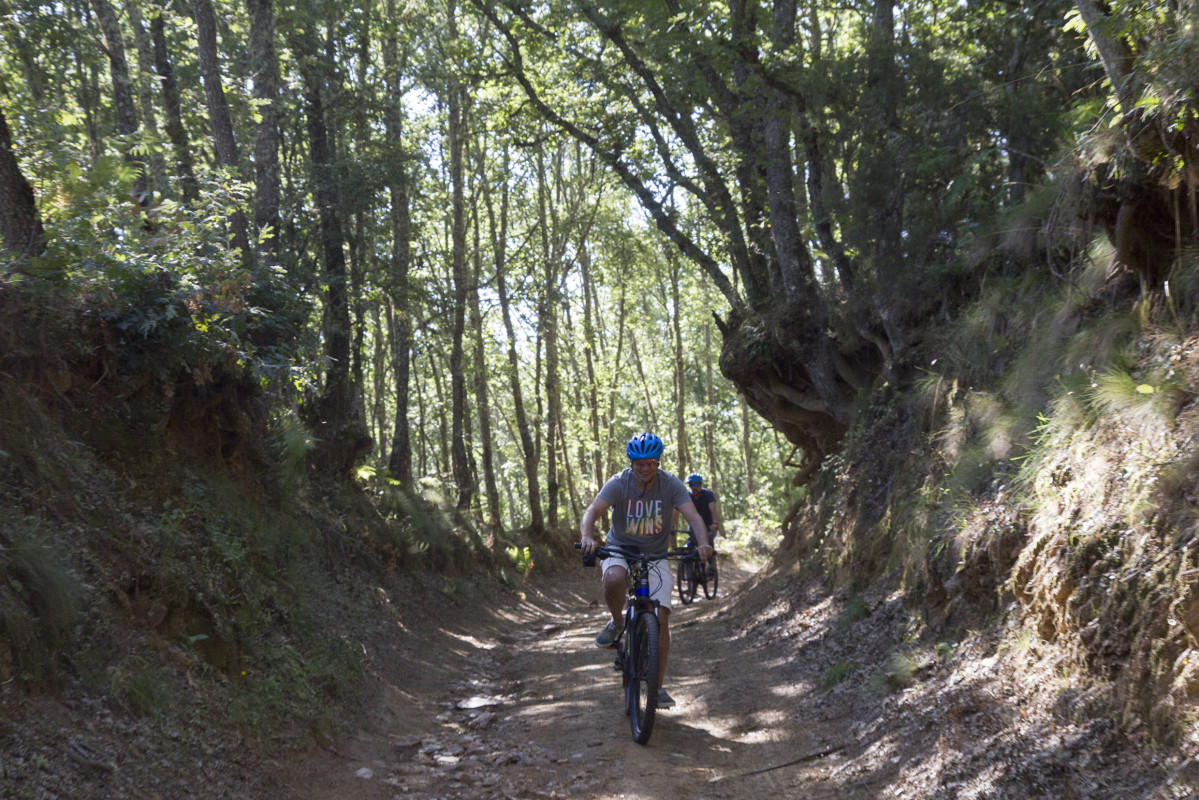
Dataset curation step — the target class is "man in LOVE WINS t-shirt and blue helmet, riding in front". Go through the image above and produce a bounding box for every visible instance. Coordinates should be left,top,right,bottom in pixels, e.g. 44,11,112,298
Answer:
579,432,712,709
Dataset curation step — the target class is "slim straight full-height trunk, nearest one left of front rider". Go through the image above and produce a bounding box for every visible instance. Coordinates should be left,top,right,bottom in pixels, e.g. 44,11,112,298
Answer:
447,0,475,511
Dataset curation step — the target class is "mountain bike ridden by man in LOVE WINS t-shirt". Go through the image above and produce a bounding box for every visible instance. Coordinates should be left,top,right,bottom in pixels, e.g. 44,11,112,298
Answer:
574,542,695,745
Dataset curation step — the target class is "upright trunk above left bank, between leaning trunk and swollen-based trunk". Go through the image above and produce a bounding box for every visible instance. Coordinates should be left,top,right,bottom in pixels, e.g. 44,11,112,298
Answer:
246,0,283,263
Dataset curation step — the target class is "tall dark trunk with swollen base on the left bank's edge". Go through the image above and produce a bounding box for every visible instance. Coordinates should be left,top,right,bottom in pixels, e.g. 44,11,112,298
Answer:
296,25,370,476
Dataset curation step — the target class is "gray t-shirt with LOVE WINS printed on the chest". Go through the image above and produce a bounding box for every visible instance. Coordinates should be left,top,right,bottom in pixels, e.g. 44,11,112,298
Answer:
600,469,691,553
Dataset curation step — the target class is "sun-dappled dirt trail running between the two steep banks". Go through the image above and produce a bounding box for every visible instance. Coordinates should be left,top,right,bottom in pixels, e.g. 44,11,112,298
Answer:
274,567,868,800
